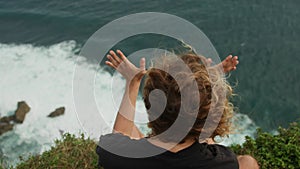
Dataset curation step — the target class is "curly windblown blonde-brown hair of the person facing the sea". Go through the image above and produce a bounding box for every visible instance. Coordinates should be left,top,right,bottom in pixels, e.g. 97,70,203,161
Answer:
143,53,233,143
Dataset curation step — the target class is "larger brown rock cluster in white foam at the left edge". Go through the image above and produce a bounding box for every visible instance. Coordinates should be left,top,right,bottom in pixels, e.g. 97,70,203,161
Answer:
0,101,30,135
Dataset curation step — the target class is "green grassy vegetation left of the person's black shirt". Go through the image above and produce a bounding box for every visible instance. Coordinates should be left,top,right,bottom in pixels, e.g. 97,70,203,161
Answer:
17,134,98,169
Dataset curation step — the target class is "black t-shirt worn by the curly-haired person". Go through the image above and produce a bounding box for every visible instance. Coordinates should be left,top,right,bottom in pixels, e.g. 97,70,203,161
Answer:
96,134,239,169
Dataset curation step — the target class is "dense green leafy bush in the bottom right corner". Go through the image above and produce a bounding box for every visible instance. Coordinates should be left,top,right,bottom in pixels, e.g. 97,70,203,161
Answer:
231,122,300,169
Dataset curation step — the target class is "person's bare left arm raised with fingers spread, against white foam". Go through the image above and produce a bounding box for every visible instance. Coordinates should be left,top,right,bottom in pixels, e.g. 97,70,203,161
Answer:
105,50,146,139
